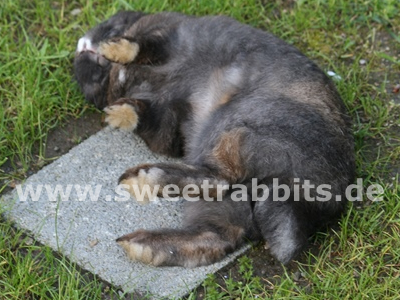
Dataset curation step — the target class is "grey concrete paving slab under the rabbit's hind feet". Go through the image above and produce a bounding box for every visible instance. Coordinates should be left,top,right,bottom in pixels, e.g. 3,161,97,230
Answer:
1,128,248,299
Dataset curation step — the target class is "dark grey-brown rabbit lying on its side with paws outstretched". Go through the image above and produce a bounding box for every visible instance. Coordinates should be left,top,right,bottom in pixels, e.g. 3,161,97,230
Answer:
74,11,355,268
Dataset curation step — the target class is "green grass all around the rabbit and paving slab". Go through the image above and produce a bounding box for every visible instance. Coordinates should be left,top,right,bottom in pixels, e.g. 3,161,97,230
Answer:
0,0,400,299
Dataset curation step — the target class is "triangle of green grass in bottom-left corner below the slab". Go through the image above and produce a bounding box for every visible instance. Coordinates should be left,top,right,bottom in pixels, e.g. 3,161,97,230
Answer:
0,224,108,299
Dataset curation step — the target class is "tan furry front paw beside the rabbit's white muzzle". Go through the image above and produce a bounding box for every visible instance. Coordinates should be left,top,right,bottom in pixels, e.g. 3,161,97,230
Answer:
98,39,139,64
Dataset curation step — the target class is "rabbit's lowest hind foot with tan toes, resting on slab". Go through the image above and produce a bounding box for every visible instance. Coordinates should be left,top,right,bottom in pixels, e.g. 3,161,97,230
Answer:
117,225,244,268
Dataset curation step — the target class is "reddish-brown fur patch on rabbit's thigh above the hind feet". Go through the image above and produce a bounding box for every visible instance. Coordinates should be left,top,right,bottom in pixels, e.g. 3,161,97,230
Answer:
212,128,245,182
